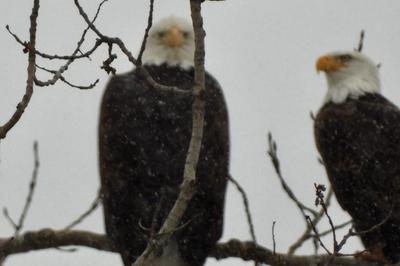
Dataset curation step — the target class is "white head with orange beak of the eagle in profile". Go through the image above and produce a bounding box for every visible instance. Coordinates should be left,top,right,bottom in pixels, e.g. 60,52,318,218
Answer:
316,51,381,103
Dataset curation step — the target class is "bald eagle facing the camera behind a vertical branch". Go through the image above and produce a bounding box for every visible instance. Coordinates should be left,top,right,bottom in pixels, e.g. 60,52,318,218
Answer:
99,17,229,266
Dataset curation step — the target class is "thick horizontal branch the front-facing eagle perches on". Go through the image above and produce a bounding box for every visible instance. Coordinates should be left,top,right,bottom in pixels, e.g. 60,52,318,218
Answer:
0,229,379,266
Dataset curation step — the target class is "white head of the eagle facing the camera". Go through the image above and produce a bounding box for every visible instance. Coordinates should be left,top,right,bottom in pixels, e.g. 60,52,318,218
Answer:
142,16,194,69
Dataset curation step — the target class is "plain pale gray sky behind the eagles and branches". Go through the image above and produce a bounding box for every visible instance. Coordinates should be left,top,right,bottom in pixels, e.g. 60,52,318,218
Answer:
0,0,400,266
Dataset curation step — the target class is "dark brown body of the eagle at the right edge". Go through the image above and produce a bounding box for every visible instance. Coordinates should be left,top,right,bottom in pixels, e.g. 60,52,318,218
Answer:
314,94,400,263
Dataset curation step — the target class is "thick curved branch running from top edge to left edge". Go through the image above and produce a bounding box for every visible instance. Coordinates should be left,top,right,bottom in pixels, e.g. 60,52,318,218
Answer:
0,0,40,139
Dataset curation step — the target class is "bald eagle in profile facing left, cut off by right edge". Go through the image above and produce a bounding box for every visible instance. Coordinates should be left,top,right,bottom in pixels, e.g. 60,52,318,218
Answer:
314,52,400,263
